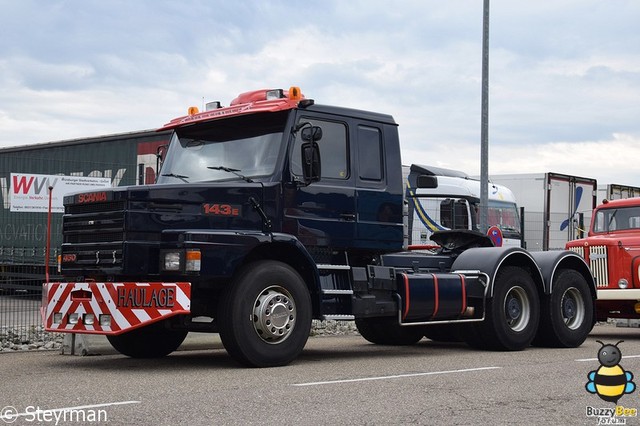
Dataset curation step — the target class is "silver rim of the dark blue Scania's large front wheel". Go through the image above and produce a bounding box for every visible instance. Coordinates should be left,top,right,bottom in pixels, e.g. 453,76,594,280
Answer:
252,286,296,344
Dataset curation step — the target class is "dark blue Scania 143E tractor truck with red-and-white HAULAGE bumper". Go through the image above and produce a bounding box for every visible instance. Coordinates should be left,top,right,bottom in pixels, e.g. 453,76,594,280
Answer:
43,87,596,367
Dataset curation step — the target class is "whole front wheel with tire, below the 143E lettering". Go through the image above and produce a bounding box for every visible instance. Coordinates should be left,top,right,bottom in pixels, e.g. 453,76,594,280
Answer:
218,260,311,367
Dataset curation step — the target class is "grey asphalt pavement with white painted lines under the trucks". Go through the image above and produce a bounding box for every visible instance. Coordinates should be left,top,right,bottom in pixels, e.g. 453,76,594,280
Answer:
0,325,640,426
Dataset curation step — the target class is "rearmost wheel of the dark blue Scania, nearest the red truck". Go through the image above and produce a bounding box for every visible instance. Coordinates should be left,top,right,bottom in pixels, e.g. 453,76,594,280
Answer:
533,269,594,348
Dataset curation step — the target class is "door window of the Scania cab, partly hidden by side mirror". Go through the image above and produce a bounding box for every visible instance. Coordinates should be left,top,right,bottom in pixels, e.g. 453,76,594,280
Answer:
291,117,349,179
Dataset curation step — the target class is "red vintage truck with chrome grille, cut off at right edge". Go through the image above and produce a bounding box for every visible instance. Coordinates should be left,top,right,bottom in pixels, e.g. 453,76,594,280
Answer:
566,198,640,321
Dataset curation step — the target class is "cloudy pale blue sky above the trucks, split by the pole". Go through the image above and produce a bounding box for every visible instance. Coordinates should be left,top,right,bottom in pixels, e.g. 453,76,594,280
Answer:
0,0,640,186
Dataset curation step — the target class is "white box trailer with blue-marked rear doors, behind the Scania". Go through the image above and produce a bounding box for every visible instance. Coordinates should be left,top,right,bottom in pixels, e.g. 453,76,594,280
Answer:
489,172,598,251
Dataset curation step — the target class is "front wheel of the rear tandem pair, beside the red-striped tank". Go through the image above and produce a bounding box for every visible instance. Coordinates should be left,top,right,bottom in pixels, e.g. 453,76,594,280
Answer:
465,266,540,351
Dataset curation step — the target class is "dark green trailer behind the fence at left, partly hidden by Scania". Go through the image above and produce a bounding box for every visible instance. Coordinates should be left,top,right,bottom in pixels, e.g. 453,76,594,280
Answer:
0,131,170,342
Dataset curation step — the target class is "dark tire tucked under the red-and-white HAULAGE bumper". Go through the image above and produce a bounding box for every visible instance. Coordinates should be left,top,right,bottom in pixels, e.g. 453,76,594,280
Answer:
107,321,188,358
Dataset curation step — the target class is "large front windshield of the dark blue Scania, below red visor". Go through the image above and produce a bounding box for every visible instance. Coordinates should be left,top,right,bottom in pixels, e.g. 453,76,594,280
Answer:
158,113,287,183
